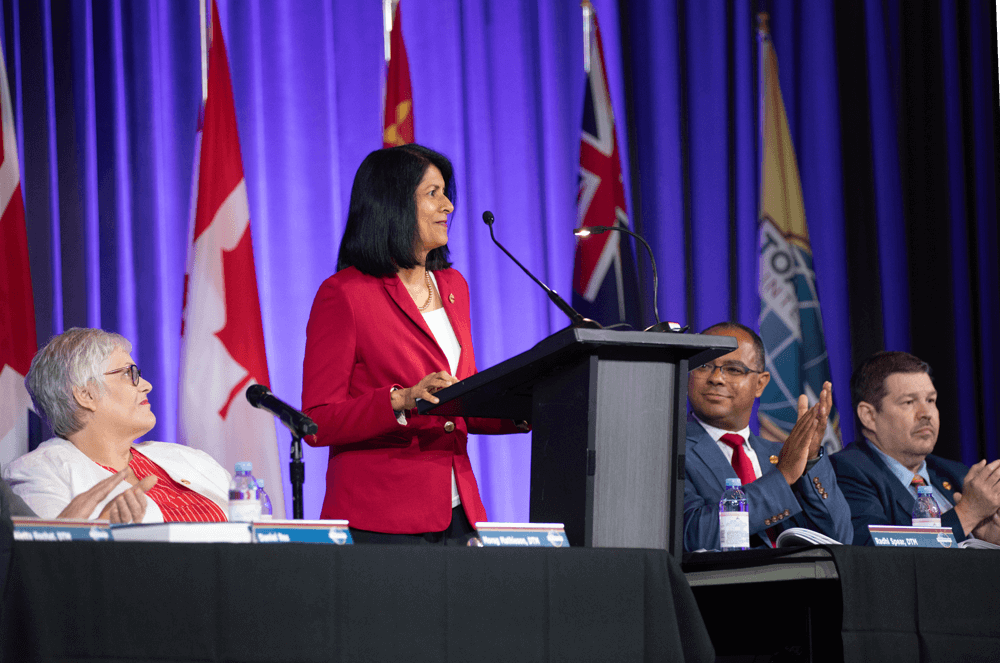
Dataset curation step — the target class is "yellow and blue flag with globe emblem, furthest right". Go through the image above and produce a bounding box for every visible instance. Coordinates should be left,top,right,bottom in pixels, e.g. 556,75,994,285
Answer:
757,14,843,453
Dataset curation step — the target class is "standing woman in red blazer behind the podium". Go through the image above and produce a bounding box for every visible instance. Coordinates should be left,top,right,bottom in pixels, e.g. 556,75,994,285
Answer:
302,145,518,544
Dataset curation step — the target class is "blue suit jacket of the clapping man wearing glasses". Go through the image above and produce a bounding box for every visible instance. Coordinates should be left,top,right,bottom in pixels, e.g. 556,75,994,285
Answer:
684,419,853,551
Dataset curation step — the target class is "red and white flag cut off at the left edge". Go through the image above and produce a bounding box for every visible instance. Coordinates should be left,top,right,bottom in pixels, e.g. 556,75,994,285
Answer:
0,39,38,466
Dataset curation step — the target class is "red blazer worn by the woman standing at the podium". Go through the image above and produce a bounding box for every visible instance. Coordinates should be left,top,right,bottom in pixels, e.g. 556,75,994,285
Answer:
302,267,519,534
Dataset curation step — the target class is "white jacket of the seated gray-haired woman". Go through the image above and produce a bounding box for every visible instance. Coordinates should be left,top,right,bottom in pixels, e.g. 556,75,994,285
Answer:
3,437,230,523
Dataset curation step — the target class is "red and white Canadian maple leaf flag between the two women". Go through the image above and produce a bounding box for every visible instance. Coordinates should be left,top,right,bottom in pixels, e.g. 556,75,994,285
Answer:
178,2,285,517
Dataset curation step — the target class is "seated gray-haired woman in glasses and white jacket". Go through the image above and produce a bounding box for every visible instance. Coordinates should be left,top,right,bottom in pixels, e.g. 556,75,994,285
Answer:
3,328,230,523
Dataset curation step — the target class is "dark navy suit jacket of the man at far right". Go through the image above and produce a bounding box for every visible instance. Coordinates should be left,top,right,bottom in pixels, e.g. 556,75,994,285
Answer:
830,439,969,546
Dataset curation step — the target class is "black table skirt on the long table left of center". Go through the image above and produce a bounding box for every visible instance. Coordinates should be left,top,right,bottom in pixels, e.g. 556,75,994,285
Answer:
0,542,714,662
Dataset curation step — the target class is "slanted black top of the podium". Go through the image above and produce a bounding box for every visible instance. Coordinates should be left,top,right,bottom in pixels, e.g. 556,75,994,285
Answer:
417,327,737,421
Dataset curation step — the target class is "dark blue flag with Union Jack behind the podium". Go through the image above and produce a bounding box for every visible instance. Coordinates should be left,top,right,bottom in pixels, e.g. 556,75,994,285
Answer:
573,13,641,329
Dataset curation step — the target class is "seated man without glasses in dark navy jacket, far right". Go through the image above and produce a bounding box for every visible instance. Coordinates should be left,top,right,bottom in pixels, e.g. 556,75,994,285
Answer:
831,352,1000,545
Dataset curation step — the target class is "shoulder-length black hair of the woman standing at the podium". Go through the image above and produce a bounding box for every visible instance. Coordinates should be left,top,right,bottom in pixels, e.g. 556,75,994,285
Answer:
337,144,456,276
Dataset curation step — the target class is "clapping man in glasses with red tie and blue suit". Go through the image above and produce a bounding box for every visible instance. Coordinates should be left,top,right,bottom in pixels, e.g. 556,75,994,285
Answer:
684,322,853,551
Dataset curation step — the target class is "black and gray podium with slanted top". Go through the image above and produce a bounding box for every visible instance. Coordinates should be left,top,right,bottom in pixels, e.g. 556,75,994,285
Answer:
418,327,736,559
